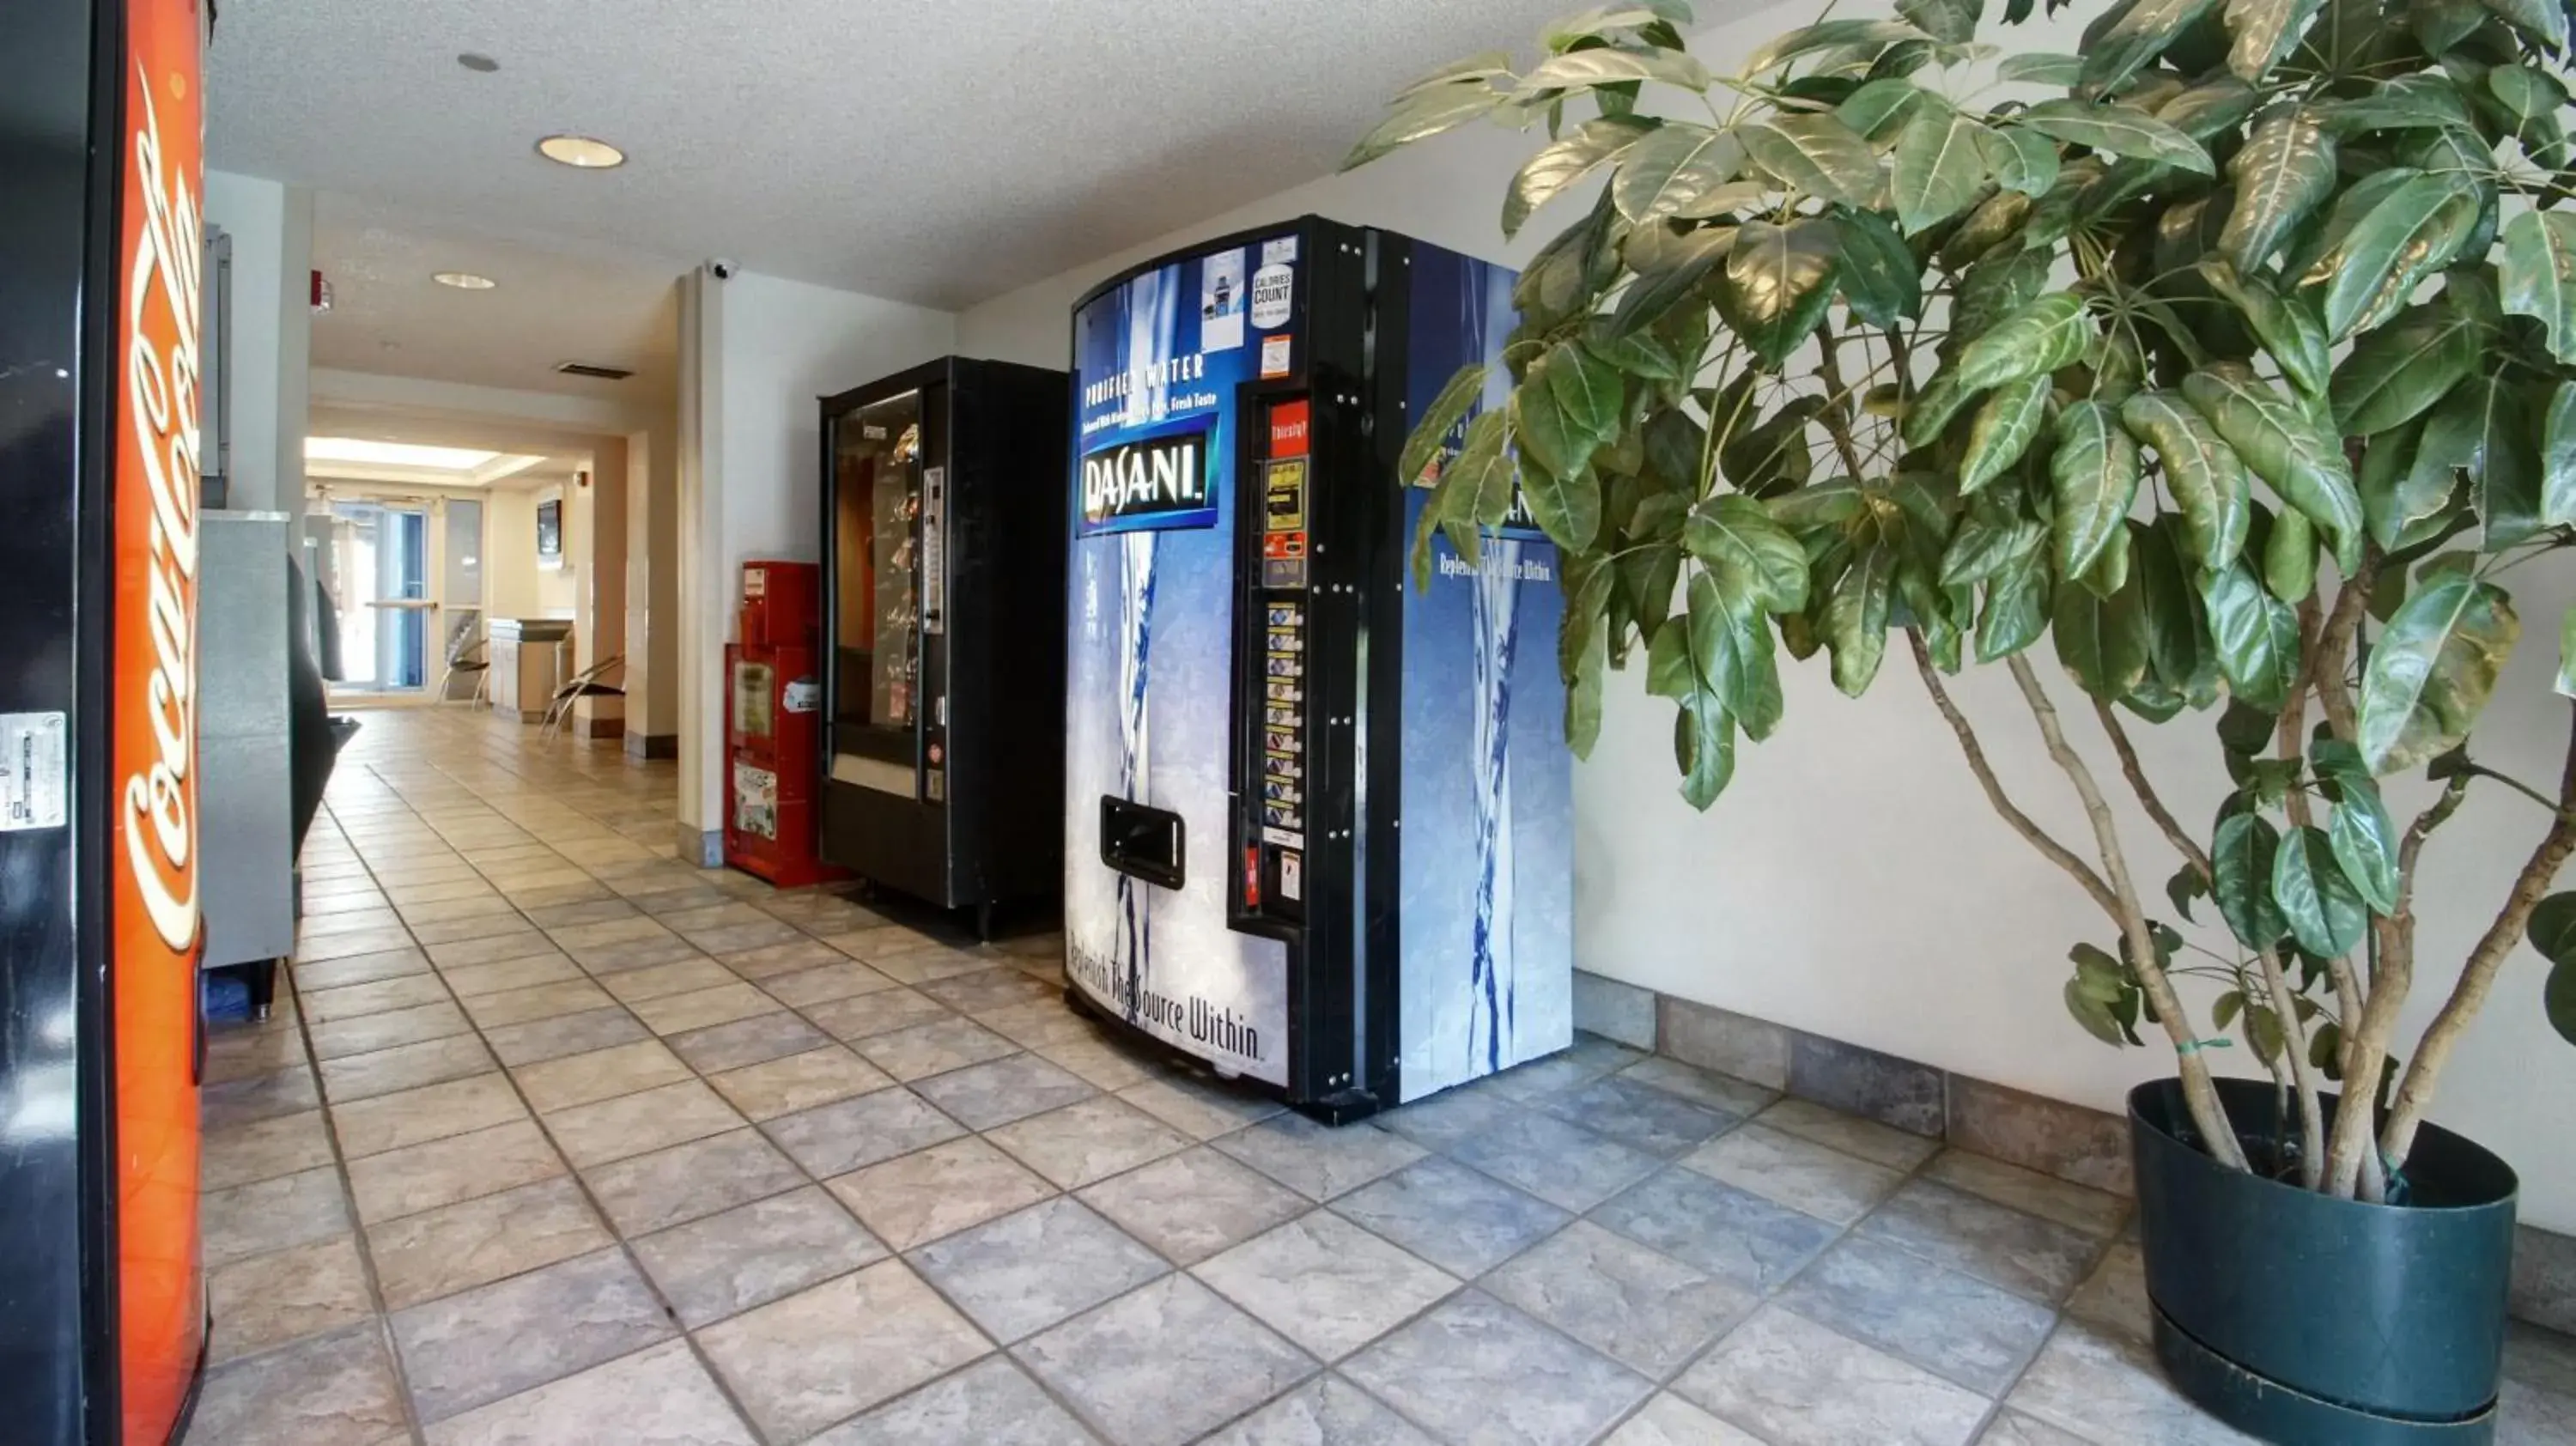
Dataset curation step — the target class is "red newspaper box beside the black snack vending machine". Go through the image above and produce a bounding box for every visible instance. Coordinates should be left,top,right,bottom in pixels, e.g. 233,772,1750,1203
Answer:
724,562,848,890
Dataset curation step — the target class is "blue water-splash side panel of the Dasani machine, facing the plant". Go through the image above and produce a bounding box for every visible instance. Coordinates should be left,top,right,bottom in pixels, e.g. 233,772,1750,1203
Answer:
1401,245,1574,1101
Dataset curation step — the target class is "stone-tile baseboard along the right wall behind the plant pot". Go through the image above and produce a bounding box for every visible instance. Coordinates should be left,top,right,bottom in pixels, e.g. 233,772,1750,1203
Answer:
1574,969,2576,1333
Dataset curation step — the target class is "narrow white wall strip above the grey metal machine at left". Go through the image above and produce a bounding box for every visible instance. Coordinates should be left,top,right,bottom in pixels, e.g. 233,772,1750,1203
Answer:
206,170,314,513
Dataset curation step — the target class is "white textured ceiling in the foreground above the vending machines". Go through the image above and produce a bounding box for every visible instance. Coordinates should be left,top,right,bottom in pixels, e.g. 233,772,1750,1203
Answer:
206,0,1571,310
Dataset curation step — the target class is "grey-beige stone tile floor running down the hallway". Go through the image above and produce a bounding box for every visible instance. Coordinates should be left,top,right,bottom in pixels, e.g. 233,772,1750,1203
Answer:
188,714,2576,1446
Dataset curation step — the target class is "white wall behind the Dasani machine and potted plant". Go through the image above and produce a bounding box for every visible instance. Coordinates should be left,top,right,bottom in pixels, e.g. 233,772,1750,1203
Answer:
958,5,2576,1230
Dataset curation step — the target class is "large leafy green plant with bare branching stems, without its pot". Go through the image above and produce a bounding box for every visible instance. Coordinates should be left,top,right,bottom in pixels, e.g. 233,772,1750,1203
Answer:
1347,0,2576,1201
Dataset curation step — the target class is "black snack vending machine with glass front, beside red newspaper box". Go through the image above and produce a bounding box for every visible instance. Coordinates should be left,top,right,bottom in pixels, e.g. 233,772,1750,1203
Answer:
822,355,1069,936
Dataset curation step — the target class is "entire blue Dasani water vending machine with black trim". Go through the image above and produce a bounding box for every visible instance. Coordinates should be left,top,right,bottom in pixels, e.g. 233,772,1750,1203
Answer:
1064,216,1574,1119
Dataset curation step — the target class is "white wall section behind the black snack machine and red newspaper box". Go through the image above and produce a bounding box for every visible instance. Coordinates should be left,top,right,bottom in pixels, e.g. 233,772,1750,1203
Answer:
680,270,956,833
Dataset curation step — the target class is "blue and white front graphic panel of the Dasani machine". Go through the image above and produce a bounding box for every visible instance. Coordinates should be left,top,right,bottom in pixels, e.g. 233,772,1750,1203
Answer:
1064,240,1293,1085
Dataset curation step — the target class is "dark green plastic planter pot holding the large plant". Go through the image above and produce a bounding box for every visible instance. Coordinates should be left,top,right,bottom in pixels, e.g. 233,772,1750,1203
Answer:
2128,1080,2517,1446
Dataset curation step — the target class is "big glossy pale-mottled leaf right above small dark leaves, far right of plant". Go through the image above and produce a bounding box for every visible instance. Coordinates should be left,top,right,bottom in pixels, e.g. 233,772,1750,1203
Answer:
2360,569,2522,776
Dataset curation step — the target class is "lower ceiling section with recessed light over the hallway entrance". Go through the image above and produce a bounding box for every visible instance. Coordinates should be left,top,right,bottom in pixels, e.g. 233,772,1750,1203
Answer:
309,191,683,404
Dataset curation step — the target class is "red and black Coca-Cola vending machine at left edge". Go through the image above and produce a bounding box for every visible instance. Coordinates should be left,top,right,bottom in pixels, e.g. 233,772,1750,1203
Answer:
0,0,209,1446
